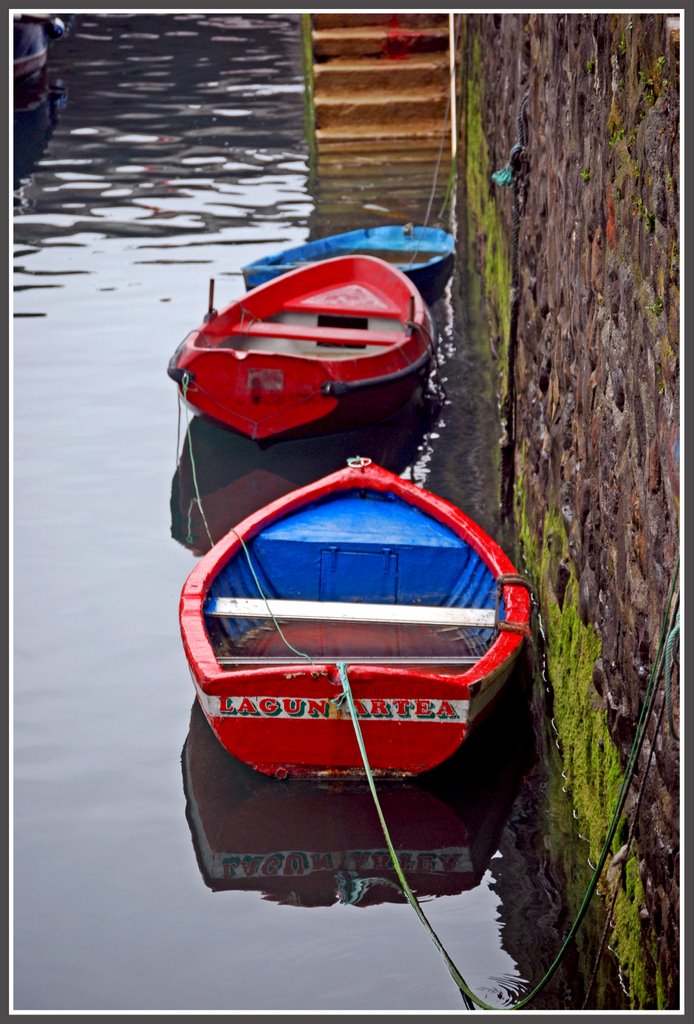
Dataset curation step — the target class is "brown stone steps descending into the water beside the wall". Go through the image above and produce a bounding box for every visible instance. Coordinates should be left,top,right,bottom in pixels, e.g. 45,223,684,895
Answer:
306,11,451,233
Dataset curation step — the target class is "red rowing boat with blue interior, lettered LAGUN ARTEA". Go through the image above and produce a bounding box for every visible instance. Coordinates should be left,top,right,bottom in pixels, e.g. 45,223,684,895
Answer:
180,459,530,777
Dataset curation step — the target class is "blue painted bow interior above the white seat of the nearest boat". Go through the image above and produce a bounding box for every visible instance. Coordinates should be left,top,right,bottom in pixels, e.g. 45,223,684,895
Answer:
210,490,505,638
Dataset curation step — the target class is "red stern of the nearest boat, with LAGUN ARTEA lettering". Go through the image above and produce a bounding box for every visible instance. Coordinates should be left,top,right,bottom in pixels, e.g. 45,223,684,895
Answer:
193,647,520,778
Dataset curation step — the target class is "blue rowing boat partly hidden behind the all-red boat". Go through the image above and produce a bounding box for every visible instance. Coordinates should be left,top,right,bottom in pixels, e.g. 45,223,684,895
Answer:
242,224,454,304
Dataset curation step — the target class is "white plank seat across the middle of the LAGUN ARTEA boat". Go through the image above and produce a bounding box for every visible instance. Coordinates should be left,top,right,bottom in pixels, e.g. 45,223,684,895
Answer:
204,597,497,628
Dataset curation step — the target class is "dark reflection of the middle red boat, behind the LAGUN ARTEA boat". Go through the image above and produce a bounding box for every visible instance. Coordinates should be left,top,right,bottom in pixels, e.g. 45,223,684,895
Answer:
171,399,436,555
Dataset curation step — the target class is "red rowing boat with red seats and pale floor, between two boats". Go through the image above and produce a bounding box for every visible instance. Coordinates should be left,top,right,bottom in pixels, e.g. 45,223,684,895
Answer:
168,256,436,440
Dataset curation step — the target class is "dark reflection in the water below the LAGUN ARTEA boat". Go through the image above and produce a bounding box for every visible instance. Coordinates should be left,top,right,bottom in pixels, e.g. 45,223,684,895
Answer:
181,679,532,907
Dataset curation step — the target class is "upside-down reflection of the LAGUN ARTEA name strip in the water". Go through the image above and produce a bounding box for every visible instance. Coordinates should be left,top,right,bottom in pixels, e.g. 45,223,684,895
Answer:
215,847,472,879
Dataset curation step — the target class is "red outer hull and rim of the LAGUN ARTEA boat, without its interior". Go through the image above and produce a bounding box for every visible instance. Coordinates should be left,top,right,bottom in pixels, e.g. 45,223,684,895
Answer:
180,465,530,777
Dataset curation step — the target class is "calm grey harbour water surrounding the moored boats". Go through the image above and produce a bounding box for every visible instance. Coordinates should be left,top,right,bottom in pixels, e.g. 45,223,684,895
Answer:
12,12,622,1013
